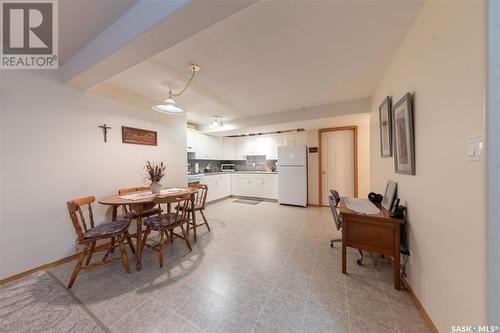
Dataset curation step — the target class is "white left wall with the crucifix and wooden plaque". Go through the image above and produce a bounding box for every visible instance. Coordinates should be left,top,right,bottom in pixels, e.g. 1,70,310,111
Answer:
0,70,187,278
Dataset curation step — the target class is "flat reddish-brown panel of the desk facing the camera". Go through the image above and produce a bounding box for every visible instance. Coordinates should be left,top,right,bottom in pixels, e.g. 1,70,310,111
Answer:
346,220,395,251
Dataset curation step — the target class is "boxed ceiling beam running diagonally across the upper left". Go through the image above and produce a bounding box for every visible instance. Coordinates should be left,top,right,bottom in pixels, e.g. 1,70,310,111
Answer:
62,0,255,90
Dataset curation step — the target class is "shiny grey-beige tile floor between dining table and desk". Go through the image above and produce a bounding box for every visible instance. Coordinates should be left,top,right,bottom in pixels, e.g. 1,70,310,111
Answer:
11,199,428,333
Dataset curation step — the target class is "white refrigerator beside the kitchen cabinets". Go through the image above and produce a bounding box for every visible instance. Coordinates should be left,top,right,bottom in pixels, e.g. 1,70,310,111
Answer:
278,145,307,207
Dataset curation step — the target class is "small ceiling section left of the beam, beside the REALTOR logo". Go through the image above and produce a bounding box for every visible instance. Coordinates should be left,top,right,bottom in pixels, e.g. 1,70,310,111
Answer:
58,0,138,64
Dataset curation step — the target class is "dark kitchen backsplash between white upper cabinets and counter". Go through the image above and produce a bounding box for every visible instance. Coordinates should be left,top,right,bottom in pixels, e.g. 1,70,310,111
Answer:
187,155,278,172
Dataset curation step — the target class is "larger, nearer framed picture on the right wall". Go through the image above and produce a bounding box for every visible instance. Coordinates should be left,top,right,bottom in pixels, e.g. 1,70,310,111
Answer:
392,93,415,175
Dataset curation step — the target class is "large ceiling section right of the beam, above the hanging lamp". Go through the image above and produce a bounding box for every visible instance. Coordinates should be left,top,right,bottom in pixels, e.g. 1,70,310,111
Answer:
93,1,422,124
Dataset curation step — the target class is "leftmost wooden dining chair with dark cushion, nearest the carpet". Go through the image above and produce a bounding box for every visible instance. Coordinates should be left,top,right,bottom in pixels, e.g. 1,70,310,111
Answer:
67,196,134,289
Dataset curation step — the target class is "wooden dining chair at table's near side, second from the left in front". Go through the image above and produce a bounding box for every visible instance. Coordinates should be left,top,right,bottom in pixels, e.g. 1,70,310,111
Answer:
142,193,192,267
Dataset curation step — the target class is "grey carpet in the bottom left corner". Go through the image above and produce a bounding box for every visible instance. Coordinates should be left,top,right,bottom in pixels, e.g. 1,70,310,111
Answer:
0,271,109,332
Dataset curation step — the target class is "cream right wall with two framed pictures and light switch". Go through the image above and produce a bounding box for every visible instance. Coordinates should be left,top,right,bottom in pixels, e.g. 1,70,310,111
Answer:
370,1,487,332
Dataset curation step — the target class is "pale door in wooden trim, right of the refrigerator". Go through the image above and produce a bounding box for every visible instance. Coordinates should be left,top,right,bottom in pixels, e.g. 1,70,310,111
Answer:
321,130,355,206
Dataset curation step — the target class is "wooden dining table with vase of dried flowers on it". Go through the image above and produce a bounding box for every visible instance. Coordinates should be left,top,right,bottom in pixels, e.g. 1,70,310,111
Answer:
98,187,198,271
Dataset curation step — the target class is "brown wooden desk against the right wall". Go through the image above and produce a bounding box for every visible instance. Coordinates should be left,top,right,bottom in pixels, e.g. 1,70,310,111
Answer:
339,199,405,290
